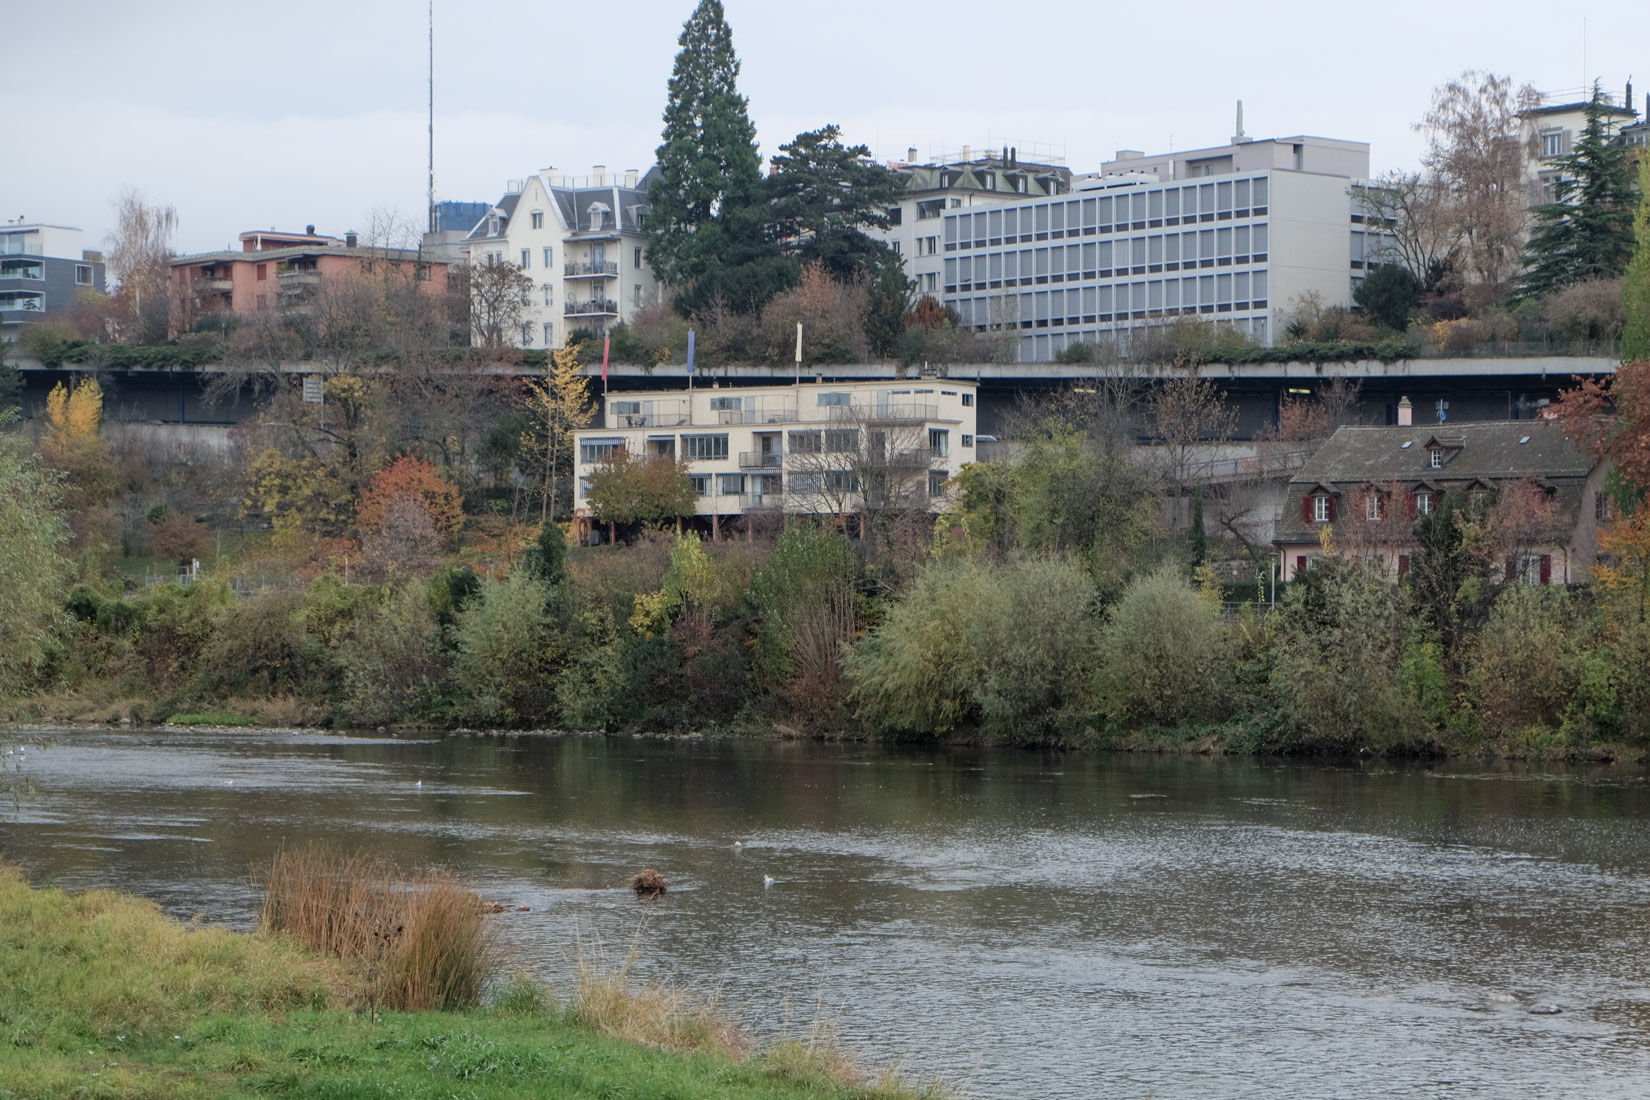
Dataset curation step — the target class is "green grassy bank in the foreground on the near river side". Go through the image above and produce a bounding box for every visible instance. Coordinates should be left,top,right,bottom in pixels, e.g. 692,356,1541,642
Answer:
0,866,927,1100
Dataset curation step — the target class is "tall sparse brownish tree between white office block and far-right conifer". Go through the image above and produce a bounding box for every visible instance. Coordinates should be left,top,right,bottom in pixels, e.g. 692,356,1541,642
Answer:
1416,69,1538,296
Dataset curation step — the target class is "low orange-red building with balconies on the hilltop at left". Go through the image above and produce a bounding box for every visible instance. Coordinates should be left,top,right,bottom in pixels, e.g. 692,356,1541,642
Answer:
172,226,447,333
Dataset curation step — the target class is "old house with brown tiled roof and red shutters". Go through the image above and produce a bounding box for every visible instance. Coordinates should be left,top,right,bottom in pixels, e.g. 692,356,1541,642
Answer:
1272,421,1610,584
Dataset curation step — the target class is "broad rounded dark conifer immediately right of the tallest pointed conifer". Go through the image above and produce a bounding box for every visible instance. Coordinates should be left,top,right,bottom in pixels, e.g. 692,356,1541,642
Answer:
766,125,904,282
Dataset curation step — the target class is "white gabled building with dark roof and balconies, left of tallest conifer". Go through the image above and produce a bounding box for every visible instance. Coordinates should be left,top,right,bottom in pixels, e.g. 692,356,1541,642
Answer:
465,165,660,348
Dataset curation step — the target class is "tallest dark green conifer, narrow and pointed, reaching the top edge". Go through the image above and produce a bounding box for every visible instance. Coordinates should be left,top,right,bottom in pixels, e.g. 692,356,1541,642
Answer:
644,0,771,287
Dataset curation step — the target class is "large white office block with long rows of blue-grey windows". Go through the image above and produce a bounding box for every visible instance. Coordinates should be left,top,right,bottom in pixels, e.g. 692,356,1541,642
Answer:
941,134,1376,361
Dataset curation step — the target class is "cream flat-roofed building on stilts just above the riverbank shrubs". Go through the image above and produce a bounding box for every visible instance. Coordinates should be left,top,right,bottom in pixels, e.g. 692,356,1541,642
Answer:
574,378,975,533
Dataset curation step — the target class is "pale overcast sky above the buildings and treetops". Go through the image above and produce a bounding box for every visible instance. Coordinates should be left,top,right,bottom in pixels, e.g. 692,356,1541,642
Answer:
0,0,1650,252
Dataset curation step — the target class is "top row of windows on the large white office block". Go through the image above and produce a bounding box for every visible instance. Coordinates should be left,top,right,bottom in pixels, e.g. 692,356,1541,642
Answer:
943,176,1269,252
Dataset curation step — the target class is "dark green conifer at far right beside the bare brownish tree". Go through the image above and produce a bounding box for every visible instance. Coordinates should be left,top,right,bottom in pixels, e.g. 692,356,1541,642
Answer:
1518,84,1638,299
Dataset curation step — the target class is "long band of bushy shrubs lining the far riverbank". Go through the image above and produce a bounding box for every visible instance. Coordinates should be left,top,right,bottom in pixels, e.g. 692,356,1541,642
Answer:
12,501,1650,757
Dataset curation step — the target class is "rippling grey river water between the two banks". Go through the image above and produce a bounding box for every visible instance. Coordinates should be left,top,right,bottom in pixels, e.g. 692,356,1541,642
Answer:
0,731,1650,1098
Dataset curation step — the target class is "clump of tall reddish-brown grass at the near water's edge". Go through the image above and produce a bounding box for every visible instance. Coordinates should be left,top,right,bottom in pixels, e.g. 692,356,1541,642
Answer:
262,844,500,1011
